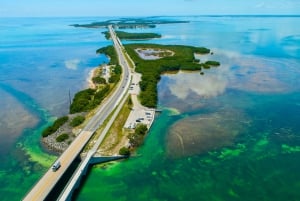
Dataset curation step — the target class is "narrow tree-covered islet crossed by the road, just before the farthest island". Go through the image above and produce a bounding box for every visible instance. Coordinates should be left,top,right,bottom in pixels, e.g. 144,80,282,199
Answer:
103,31,161,40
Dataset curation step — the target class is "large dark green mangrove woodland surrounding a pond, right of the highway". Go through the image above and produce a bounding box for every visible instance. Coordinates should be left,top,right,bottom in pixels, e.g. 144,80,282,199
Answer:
125,44,210,107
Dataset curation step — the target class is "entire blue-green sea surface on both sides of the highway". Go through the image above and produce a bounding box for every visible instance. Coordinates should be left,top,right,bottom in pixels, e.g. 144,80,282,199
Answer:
0,16,300,201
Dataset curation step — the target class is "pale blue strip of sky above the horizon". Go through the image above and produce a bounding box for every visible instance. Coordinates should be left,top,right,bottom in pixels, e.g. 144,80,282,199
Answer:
0,0,300,17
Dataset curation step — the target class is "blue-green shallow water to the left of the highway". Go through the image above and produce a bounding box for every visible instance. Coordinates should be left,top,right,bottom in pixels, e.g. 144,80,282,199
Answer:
0,18,110,200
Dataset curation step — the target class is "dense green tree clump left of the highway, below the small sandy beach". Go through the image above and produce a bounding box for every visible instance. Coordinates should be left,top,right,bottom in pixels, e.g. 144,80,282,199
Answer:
70,85,110,114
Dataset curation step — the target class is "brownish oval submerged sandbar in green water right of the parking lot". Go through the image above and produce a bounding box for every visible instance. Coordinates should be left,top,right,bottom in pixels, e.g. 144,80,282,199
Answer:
166,110,247,158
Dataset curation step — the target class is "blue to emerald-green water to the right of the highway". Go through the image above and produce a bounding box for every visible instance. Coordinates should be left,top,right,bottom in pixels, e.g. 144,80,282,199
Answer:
76,17,300,201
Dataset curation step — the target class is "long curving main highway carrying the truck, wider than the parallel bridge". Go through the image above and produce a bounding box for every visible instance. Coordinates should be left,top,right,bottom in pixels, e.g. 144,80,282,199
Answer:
23,26,131,201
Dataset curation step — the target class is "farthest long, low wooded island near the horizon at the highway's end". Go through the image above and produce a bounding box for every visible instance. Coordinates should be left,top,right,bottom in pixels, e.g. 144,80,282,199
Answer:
71,18,189,29
